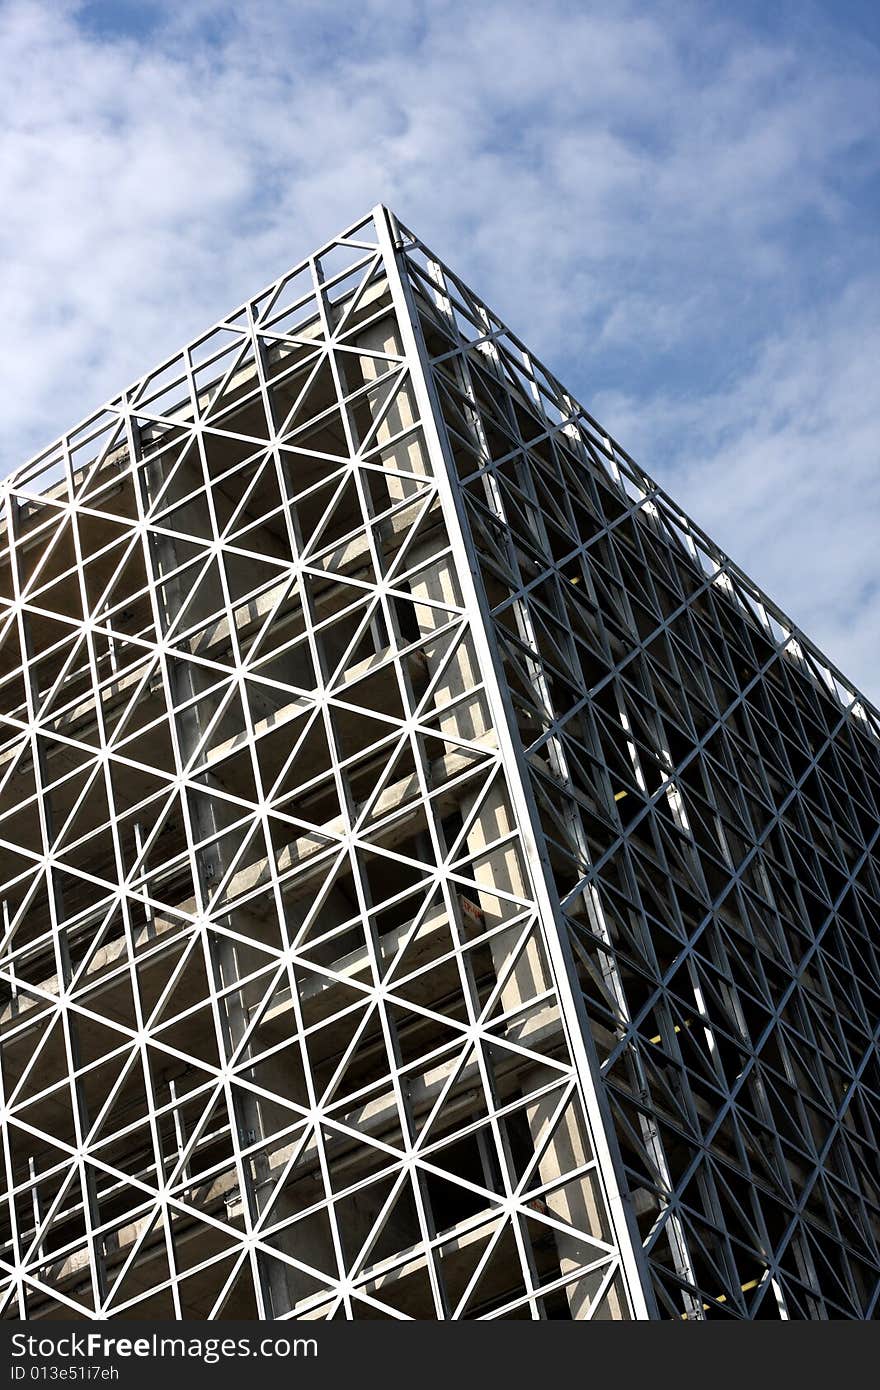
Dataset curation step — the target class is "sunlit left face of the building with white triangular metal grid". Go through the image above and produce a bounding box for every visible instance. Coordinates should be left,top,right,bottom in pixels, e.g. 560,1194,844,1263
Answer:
0,210,633,1319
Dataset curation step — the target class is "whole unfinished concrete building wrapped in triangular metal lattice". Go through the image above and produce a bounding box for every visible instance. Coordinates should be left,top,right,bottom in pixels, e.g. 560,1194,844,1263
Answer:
0,209,880,1319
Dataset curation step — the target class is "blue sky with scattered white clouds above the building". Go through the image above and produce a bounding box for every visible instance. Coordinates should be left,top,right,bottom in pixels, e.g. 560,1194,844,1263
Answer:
0,0,880,702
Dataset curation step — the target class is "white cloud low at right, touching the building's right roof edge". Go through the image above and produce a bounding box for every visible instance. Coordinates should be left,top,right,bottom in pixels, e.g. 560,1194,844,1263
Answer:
596,278,880,692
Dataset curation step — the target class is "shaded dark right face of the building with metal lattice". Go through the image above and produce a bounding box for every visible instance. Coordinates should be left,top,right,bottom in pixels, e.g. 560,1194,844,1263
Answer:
399,214,880,1319
